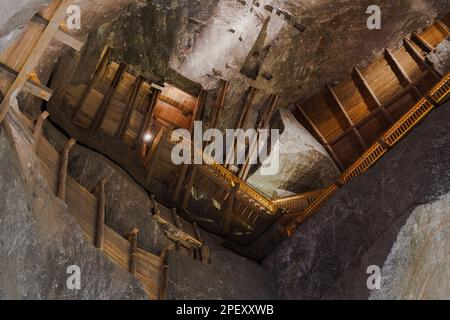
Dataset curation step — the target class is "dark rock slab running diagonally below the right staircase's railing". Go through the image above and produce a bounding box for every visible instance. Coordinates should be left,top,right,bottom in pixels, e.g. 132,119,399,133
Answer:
264,103,450,299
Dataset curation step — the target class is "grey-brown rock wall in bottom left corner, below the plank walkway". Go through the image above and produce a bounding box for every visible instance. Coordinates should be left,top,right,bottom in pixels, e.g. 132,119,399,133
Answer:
0,119,146,299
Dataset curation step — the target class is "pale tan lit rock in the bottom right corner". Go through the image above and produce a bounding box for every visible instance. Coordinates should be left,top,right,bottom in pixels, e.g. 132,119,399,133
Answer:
370,194,450,300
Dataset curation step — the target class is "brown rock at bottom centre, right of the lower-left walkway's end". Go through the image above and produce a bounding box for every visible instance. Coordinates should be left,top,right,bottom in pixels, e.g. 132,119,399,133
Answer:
167,251,276,300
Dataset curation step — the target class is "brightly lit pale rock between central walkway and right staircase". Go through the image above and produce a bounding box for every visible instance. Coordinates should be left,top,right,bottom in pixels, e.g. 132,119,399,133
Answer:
248,110,339,195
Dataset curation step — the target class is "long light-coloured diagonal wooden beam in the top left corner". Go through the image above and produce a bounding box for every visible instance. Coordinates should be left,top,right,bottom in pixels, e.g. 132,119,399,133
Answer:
0,0,70,123
